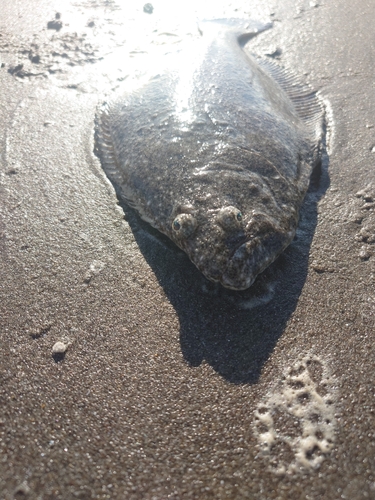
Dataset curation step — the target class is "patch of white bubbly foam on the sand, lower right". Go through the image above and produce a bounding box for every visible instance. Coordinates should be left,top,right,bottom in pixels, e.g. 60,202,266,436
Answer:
254,356,336,474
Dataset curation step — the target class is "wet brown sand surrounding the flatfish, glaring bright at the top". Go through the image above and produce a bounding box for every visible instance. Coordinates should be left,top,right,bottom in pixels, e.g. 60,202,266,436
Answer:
0,0,375,500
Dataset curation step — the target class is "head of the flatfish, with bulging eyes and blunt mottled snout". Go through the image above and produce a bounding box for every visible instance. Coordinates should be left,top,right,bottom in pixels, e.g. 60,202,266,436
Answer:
168,174,298,290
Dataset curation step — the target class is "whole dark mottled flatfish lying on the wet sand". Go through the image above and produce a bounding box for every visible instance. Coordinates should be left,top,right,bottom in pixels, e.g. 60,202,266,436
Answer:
96,20,322,290
